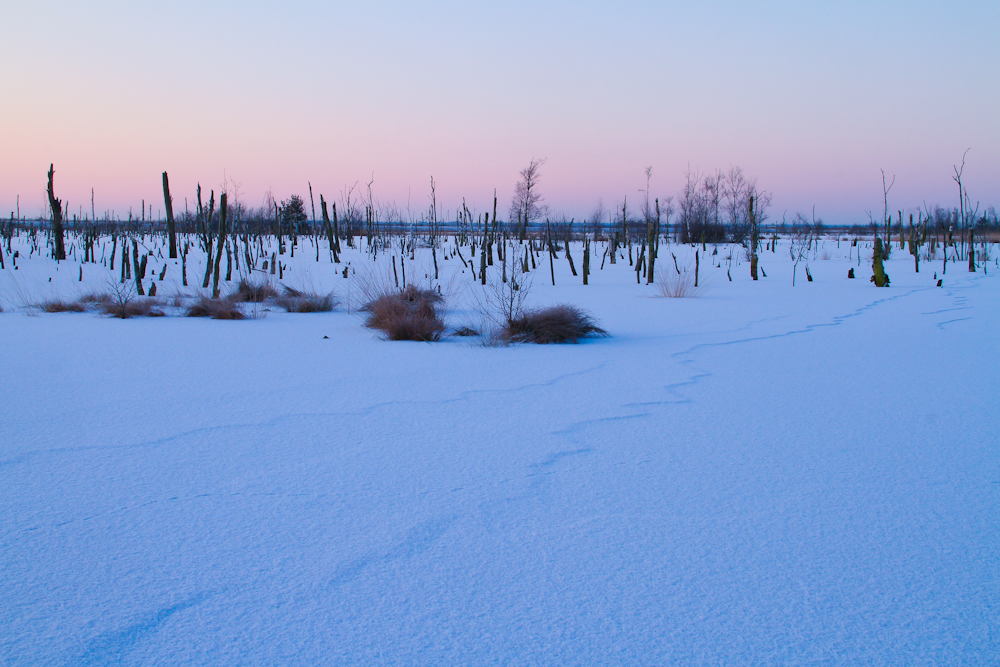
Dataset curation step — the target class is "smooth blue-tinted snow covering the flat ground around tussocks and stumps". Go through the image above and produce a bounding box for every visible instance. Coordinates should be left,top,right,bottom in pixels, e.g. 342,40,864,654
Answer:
0,232,1000,666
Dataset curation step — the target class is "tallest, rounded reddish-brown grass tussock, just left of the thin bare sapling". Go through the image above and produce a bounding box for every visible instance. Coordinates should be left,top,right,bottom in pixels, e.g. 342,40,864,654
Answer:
361,285,445,341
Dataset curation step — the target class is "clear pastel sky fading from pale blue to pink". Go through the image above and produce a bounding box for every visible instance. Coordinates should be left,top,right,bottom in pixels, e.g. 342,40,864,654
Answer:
0,0,1000,223
